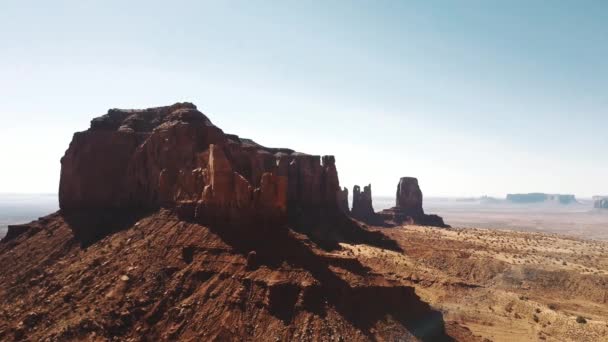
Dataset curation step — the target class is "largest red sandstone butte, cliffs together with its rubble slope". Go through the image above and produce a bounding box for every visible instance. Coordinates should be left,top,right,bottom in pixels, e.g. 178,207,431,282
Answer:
0,103,476,341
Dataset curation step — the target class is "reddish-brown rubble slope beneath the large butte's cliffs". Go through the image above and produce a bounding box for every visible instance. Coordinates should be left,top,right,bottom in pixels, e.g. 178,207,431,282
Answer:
0,210,486,341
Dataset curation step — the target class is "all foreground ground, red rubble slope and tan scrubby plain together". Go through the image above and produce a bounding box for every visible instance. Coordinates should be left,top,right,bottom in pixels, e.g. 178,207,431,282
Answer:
0,210,608,341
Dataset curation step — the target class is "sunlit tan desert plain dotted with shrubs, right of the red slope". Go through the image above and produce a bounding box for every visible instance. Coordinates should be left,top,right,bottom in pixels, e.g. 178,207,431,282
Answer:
342,226,608,341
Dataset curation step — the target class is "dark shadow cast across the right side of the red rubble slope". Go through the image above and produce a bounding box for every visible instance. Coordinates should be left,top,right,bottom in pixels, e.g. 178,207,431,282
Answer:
187,215,451,341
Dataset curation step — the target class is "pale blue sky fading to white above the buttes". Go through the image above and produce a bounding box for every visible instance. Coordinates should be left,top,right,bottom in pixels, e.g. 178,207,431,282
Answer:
0,0,608,197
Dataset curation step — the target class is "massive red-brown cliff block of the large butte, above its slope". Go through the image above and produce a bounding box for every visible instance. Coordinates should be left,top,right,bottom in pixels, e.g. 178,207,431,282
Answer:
59,103,341,224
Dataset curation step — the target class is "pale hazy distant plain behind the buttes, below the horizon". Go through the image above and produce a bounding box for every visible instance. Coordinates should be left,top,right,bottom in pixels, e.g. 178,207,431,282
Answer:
0,193,608,240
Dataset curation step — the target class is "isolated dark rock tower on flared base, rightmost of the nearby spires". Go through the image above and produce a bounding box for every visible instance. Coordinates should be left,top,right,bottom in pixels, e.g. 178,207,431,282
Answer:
378,177,449,227
